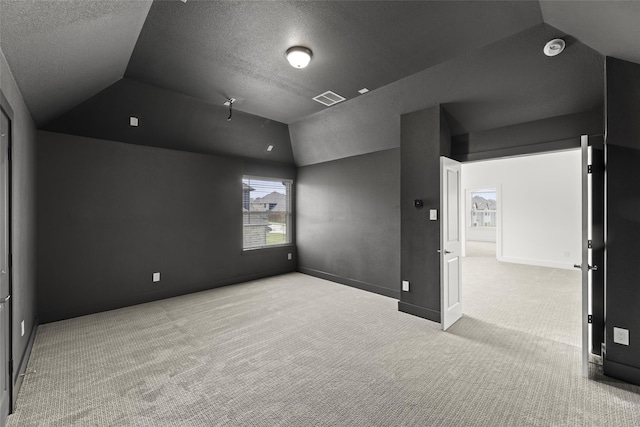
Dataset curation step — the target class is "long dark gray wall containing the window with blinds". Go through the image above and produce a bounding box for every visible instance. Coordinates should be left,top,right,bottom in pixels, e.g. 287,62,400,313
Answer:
37,131,295,322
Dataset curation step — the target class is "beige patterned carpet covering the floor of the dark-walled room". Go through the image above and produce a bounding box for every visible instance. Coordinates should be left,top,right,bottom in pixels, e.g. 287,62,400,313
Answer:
8,273,640,427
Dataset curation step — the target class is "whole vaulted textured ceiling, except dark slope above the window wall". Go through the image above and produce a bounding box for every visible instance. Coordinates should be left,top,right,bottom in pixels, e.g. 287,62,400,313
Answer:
0,0,640,164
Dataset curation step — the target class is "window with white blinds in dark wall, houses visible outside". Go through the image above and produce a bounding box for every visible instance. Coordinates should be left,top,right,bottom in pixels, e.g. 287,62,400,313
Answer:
242,176,293,249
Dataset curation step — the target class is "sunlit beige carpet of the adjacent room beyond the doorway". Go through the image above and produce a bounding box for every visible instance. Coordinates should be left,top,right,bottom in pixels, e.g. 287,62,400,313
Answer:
462,242,582,347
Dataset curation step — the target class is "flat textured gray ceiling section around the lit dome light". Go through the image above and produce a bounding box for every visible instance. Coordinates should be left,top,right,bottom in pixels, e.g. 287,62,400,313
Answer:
126,1,542,123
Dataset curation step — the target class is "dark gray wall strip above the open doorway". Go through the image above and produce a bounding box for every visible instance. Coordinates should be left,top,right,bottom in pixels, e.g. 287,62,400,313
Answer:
451,108,604,162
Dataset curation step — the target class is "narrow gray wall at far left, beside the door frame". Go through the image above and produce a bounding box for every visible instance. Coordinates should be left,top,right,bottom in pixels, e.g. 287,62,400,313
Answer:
0,51,37,400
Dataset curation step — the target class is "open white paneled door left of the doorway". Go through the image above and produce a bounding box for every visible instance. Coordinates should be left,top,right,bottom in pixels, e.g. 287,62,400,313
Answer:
440,157,462,331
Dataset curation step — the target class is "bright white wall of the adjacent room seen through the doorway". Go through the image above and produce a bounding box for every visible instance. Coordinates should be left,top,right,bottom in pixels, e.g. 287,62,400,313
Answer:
462,149,582,268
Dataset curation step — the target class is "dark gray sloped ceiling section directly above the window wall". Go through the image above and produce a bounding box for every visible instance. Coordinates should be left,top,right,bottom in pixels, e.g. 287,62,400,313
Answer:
44,78,293,164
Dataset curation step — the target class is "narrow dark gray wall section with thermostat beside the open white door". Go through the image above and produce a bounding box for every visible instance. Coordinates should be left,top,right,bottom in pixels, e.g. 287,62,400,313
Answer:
398,105,450,322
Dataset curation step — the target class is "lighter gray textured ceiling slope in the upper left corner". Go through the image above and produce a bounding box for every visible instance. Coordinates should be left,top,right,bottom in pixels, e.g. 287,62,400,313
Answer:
0,0,151,126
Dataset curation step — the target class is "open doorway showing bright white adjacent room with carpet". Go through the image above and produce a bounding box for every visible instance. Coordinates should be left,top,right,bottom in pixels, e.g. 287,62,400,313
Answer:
461,150,581,347
